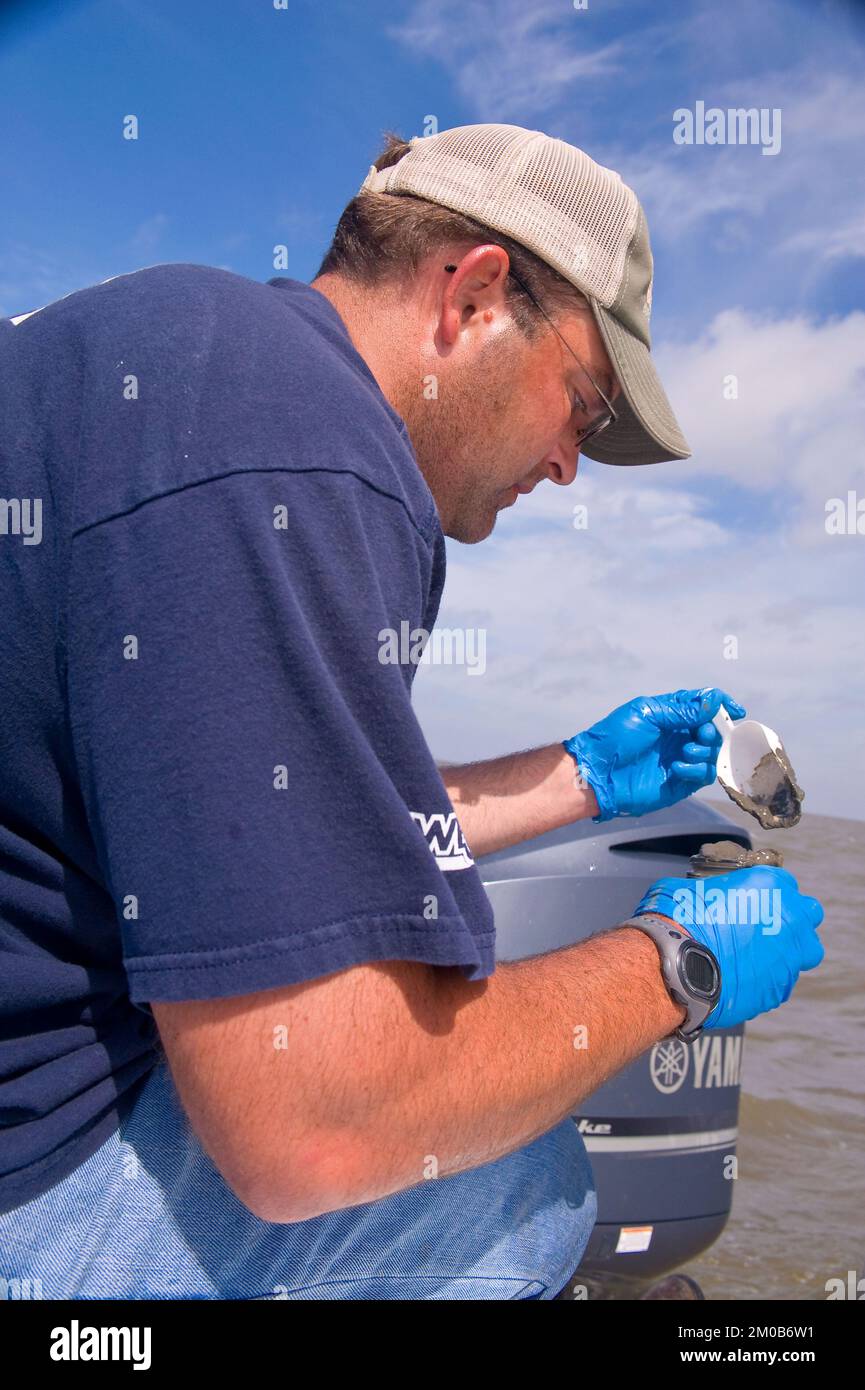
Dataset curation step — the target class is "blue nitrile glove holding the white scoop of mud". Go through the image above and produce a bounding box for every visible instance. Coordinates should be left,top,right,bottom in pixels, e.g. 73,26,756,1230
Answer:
563,687,745,821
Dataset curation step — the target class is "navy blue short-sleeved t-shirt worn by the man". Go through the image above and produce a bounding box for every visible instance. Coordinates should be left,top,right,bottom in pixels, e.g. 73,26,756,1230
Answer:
0,265,494,1211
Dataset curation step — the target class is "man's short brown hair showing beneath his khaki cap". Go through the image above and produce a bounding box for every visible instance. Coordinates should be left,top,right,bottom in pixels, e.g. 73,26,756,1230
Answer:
317,131,585,338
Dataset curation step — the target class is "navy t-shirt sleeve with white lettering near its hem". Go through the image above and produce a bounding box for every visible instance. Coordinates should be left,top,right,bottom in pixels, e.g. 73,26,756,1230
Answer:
65,467,494,1002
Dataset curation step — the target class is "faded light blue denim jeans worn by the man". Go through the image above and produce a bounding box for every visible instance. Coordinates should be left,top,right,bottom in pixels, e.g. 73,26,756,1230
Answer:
0,1062,597,1300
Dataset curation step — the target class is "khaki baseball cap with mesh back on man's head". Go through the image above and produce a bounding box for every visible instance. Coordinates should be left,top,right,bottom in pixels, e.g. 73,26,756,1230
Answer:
360,125,691,464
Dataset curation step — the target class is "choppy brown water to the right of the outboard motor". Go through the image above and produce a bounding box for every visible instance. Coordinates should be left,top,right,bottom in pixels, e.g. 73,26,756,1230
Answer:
684,799,865,1300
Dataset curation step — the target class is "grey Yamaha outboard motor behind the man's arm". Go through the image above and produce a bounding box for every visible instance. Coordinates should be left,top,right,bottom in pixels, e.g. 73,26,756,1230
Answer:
478,798,751,1279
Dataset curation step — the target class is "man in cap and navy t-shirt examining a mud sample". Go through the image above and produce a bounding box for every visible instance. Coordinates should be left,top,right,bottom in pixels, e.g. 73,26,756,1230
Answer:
0,125,822,1298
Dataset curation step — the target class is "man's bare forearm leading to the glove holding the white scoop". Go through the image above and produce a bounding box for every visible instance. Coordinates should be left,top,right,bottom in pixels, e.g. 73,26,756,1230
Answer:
439,744,598,855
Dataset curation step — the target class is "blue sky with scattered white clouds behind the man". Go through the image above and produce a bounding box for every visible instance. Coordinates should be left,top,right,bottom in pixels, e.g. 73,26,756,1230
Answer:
0,0,865,817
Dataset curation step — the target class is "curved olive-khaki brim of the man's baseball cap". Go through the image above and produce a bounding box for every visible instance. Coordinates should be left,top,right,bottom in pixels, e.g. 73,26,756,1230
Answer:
581,299,691,464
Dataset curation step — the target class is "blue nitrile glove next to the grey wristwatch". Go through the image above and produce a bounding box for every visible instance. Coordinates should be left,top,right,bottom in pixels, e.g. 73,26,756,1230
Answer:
634,866,823,1029
